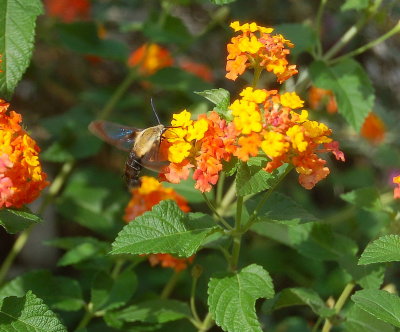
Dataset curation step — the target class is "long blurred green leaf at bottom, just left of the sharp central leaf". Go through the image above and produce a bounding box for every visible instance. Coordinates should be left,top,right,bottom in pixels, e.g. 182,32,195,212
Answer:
104,299,191,328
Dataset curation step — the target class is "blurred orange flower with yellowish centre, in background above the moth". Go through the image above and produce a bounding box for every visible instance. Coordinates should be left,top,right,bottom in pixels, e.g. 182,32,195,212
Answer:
128,44,173,76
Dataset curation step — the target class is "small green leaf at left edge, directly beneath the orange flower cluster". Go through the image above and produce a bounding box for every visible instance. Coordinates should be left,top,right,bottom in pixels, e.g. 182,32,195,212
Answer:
0,208,42,234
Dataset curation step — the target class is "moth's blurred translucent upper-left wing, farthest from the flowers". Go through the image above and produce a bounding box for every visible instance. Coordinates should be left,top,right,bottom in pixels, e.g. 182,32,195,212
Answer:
89,120,142,151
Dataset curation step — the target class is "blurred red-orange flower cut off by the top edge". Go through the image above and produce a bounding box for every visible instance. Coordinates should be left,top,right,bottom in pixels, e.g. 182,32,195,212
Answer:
45,0,90,23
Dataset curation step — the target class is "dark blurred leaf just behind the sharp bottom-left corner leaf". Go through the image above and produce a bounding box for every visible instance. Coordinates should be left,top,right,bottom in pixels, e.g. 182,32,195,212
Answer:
0,270,84,312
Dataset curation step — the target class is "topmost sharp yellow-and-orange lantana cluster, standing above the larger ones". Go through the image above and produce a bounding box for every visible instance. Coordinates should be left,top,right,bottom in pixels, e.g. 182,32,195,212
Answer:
226,21,297,83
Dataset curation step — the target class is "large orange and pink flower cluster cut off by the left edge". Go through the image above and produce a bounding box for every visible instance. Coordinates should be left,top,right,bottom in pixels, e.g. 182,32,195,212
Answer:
0,99,48,208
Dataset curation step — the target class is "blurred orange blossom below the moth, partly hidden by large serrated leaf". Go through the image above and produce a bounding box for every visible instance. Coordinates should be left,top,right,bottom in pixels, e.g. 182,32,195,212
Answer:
125,176,193,271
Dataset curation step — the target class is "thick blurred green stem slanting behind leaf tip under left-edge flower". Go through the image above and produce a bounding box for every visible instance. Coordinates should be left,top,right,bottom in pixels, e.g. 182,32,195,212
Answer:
0,161,74,285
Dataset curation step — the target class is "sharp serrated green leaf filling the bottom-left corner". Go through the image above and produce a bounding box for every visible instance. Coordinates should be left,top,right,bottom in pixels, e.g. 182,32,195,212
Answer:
0,291,67,332
